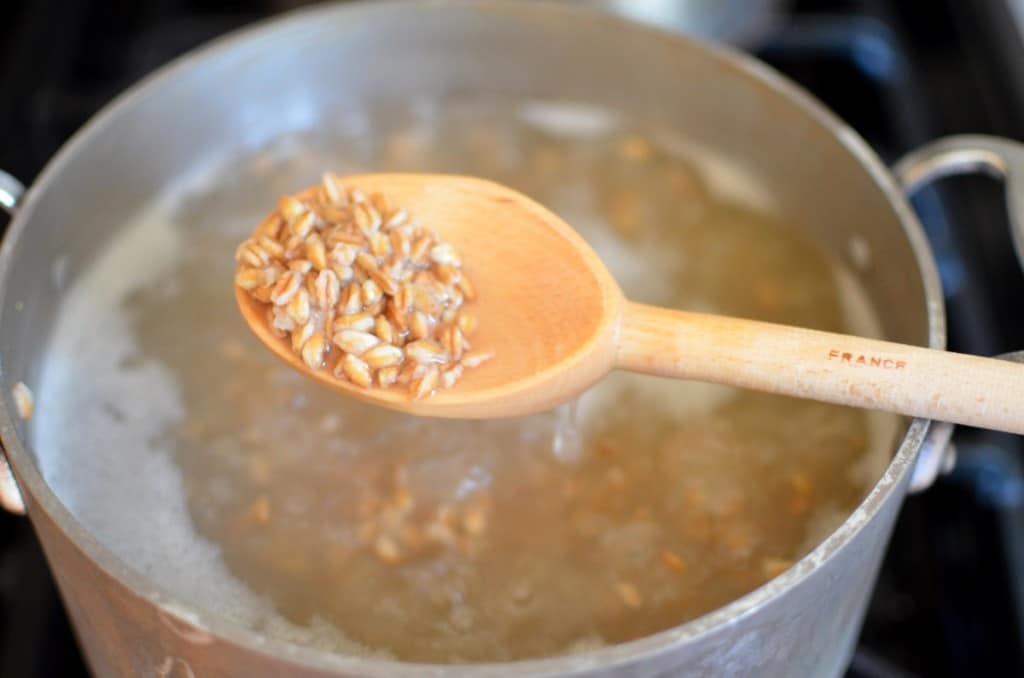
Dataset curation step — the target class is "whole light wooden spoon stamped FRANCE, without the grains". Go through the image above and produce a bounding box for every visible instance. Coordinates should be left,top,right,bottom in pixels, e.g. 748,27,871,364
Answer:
236,174,1024,433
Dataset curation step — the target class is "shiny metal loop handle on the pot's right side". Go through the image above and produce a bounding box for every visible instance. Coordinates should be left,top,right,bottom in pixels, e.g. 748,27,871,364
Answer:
893,134,1024,493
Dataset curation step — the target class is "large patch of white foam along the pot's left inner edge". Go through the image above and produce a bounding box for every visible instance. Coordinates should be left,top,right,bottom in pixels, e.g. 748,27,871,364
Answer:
32,195,382,656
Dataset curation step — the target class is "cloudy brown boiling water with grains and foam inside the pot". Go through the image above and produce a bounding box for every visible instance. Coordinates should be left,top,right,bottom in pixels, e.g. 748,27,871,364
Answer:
33,102,896,662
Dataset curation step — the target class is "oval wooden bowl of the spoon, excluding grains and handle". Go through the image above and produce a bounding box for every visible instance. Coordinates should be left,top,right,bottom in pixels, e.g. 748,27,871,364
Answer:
234,174,624,419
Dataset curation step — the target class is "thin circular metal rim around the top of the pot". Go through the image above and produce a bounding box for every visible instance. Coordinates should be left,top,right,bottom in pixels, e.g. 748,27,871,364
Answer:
0,0,945,676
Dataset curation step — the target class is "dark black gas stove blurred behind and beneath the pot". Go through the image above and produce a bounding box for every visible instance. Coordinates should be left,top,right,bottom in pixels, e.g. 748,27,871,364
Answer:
0,0,1024,678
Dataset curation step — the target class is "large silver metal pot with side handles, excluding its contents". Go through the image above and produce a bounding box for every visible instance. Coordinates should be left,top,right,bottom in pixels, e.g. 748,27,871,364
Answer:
0,1,1024,678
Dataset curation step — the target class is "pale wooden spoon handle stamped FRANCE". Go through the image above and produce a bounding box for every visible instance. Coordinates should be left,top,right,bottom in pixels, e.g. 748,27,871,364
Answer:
617,303,1024,433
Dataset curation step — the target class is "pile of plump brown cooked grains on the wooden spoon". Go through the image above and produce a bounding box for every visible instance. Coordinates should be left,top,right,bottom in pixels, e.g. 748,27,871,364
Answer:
234,174,492,399
